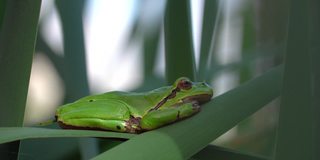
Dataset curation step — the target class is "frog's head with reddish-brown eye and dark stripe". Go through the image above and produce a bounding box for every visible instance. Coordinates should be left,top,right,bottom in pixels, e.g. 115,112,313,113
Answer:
170,77,213,104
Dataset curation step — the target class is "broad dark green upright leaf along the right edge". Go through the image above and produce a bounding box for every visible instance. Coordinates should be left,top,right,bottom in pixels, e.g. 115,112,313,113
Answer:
275,0,319,160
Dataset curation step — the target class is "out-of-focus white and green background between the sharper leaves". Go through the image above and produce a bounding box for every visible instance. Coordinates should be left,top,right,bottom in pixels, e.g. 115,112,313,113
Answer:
24,0,288,156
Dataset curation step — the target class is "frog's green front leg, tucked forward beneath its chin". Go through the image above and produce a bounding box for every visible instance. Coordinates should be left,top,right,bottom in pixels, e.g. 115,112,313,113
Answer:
140,101,200,130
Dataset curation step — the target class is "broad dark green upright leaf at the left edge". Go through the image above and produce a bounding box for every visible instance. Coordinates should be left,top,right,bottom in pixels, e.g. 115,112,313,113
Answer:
0,0,41,126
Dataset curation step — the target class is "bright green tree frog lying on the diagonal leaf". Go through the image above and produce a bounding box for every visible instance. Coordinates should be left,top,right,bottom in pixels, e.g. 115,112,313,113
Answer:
56,77,213,133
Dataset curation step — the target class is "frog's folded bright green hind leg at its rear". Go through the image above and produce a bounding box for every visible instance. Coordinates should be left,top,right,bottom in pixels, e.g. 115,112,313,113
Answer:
56,98,138,133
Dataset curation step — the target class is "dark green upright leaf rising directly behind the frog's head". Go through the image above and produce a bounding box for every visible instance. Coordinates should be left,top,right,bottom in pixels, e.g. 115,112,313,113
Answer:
164,0,195,84
